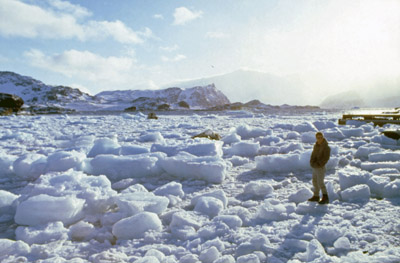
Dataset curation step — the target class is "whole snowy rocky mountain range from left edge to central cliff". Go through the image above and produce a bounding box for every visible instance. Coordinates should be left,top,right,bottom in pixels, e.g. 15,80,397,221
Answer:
0,71,230,113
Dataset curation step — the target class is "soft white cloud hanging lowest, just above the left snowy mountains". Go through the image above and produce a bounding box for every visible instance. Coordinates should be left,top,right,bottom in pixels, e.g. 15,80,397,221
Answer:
24,49,135,83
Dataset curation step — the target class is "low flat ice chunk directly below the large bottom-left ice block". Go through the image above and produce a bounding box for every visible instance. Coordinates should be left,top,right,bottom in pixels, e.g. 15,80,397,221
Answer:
15,222,68,245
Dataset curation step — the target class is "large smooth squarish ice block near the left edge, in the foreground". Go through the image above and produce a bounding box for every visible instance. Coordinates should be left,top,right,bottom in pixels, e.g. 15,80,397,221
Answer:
15,194,85,226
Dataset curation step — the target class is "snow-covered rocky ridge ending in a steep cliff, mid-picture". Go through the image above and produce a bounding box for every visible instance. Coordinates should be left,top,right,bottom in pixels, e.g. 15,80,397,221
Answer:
96,84,230,109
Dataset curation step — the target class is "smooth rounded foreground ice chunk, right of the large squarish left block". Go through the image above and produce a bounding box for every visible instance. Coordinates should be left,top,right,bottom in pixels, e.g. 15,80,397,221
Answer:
112,212,162,239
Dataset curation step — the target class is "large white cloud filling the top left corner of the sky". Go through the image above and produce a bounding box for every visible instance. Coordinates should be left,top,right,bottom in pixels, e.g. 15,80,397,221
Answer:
0,0,148,44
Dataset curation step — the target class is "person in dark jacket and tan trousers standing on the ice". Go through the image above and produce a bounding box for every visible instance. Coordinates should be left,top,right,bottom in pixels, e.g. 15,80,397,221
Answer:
308,132,331,204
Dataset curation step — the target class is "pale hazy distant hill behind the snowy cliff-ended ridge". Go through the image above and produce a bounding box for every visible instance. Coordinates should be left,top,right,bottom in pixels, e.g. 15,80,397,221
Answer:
168,69,308,105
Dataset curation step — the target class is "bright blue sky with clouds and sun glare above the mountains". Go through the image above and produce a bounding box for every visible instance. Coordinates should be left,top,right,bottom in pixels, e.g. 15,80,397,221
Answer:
0,0,400,100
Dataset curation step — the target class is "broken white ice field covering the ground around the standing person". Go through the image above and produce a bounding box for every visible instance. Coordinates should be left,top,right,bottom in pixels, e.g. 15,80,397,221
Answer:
0,112,400,263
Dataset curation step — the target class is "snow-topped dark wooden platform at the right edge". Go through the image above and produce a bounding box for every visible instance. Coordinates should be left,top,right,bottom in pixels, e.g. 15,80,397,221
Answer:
339,107,400,126
